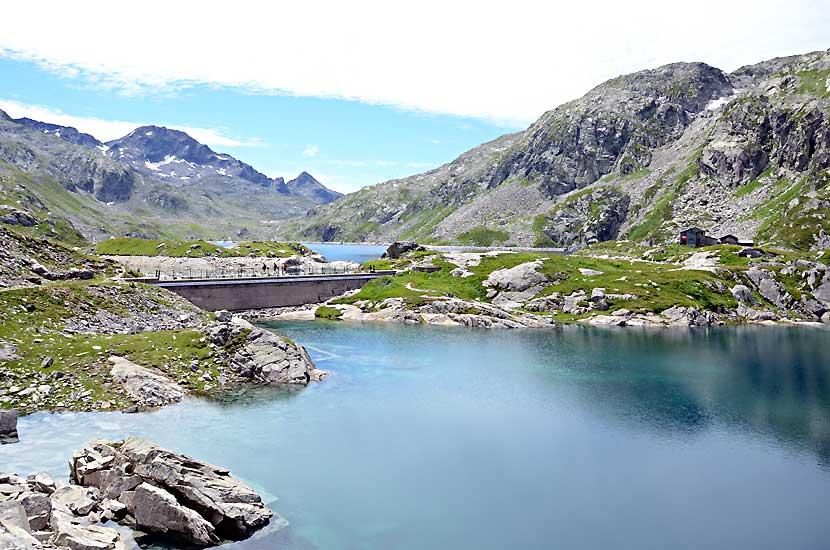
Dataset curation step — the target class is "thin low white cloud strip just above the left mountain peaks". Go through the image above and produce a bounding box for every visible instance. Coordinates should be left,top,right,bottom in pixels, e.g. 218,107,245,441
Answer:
0,99,261,147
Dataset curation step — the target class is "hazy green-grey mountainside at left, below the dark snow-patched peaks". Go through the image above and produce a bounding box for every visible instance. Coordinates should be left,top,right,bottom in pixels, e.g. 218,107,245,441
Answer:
0,113,336,242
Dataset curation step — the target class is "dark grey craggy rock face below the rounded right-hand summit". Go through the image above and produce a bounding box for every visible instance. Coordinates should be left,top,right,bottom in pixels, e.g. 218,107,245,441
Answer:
491,63,732,195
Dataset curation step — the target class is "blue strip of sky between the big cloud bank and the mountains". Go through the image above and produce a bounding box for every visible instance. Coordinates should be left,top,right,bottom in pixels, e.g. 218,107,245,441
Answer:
0,58,520,192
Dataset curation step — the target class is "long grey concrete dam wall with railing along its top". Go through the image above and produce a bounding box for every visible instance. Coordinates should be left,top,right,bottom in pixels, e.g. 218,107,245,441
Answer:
144,271,395,311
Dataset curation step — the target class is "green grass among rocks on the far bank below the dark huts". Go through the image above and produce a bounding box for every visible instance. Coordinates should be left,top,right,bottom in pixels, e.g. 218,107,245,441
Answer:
336,242,820,321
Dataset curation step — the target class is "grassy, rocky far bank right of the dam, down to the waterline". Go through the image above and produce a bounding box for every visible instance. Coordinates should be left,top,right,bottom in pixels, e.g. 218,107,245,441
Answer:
241,242,830,328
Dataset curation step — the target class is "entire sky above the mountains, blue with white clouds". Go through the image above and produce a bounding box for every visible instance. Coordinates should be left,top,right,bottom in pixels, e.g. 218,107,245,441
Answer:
0,0,830,192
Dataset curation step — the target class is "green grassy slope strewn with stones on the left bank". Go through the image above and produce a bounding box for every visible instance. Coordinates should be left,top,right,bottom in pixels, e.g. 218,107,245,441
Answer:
0,282,252,414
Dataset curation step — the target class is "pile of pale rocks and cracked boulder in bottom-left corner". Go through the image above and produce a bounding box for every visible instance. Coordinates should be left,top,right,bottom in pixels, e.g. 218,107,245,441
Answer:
0,437,285,550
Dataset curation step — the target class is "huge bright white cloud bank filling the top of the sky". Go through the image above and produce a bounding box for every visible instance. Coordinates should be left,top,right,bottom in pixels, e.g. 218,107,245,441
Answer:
0,0,830,124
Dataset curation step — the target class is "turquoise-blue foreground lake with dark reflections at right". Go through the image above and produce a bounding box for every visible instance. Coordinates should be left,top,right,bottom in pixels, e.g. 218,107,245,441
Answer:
0,322,830,550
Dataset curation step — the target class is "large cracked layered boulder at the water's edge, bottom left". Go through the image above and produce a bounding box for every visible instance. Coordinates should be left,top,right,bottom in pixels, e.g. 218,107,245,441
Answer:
70,437,273,546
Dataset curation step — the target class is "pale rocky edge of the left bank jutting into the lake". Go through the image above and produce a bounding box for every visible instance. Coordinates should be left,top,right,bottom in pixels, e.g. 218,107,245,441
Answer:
0,302,325,414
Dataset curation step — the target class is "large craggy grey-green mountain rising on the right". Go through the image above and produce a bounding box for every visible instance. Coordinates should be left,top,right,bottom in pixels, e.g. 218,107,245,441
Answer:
279,51,830,252
